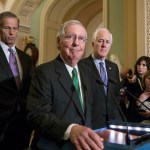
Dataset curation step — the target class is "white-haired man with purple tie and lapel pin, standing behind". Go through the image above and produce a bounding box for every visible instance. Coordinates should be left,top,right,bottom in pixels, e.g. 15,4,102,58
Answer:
81,28,122,129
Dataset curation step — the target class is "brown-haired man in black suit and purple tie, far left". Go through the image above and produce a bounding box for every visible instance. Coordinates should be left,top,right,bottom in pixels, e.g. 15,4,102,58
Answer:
0,12,32,150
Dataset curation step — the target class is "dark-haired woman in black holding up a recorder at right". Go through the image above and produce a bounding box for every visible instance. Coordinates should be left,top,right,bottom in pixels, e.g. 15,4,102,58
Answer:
123,56,150,123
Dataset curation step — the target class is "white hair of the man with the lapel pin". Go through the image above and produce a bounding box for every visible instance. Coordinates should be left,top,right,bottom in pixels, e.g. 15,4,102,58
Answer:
92,27,113,43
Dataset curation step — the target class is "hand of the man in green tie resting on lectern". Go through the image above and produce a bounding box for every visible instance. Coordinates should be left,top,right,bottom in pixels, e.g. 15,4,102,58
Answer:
70,125,104,150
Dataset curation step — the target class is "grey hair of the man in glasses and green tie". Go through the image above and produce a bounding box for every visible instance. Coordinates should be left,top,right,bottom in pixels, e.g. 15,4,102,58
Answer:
57,20,87,38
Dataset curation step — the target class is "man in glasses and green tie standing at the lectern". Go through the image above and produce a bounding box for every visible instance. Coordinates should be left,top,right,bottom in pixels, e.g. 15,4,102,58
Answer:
27,20,103,150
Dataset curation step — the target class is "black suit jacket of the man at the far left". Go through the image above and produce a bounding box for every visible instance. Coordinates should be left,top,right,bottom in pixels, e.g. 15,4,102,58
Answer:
0,46,32,150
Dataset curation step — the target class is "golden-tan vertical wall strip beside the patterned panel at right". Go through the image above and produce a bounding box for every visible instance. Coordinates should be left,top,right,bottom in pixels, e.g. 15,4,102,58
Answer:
124,0,137,68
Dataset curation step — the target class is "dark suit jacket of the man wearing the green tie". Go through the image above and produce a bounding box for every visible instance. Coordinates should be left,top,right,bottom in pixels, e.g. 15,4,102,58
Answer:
27,56,95,150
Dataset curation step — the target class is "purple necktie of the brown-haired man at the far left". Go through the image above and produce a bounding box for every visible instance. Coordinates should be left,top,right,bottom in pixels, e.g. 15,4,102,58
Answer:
8,48,20,89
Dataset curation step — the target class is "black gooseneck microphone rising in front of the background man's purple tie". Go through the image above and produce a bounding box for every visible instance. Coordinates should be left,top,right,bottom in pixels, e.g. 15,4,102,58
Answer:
96,79,130,145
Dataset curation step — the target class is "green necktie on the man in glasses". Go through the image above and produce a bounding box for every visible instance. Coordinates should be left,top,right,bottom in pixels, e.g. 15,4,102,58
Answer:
72,68,84,111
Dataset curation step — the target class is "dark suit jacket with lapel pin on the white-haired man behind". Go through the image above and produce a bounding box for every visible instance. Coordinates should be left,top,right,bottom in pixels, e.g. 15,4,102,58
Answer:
80,55,122,129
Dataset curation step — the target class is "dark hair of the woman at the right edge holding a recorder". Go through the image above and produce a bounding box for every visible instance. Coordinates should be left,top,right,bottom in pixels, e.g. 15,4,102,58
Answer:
134,56,150,75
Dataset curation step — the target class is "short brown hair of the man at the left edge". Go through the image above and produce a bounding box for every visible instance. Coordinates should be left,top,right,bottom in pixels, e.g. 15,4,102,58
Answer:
0,11,20,27
